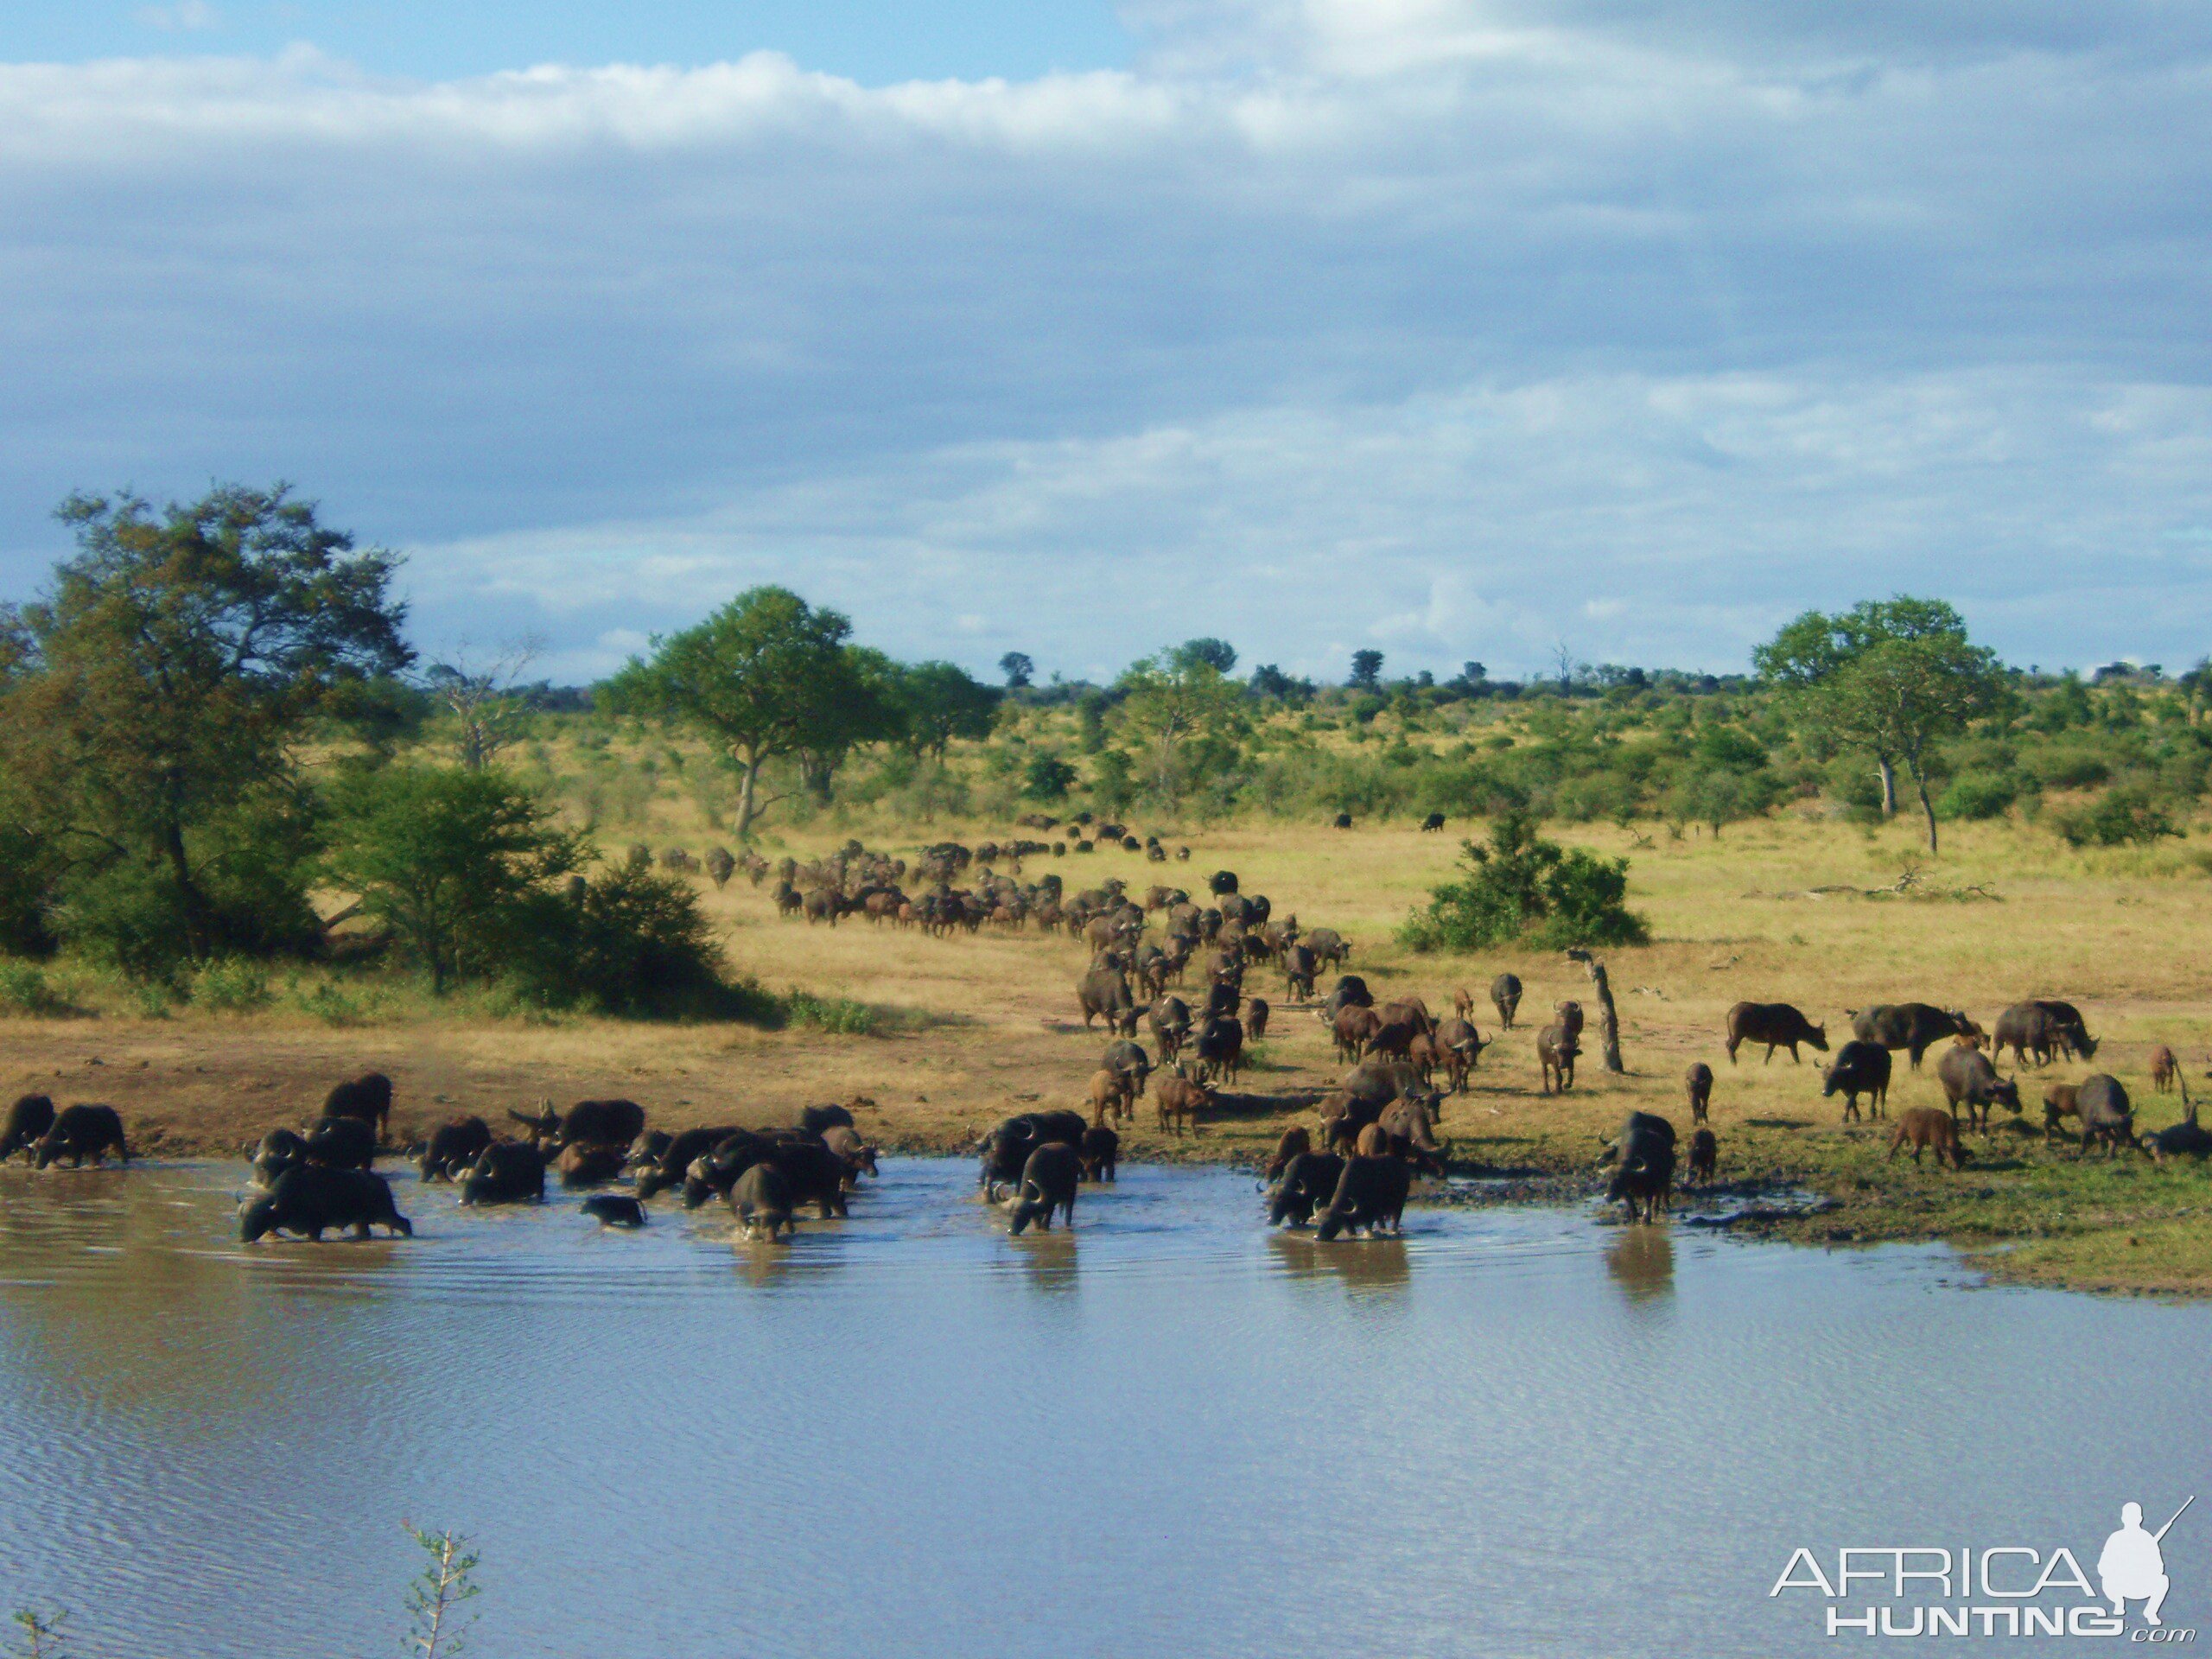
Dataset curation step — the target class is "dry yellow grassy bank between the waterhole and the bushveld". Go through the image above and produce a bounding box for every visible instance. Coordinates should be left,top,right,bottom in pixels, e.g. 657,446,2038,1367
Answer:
0,818,2212,1294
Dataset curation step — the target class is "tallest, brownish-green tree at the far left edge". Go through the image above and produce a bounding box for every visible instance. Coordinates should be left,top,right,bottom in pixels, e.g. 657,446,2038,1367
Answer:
0,485,414,960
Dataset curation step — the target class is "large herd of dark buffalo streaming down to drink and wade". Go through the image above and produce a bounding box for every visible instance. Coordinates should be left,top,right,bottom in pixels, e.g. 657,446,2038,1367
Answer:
0,831,2212,1241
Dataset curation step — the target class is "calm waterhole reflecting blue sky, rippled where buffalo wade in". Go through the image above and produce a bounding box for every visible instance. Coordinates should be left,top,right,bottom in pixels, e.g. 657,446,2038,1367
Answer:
0,1161,2212,1659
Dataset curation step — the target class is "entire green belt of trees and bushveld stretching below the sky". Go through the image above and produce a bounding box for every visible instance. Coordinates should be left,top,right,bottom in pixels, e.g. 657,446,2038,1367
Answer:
0,486,2212,1013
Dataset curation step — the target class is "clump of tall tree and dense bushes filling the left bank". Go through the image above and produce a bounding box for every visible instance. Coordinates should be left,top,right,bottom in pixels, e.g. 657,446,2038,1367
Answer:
0,486,743,1013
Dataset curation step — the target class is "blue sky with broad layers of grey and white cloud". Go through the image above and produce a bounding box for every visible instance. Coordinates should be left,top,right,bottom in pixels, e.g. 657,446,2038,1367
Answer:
0,0,2212,679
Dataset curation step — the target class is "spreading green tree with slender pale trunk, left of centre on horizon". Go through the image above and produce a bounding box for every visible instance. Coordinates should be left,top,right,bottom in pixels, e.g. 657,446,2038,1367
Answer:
606,586,882,838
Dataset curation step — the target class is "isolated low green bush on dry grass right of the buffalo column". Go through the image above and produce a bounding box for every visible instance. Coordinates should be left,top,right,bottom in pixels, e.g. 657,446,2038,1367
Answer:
1400,812,1650,951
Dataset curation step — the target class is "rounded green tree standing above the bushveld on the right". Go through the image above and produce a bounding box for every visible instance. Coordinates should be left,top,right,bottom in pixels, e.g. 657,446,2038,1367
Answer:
1754,595,2002,852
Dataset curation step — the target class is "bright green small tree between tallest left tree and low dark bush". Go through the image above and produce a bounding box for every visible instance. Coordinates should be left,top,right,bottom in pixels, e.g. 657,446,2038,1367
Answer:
327,766,580,995
